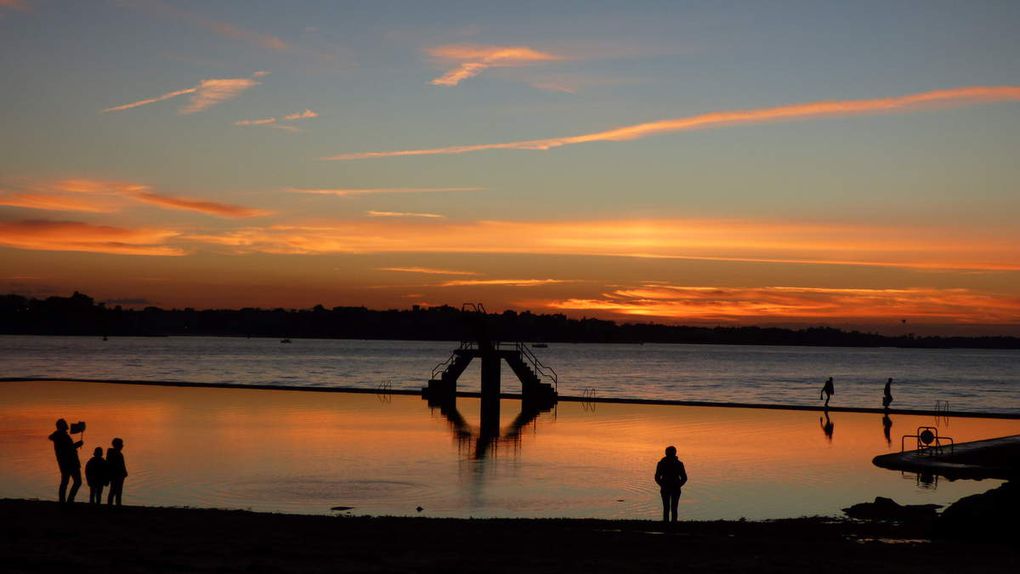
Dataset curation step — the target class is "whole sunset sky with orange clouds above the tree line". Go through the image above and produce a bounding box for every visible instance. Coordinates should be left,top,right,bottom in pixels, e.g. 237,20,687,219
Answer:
0,0,1020,335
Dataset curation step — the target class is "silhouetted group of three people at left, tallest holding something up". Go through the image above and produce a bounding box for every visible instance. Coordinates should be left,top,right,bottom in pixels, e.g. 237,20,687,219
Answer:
49,419,128,506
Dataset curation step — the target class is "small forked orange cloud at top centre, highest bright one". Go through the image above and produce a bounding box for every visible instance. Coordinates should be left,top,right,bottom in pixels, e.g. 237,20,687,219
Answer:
427,44,563,86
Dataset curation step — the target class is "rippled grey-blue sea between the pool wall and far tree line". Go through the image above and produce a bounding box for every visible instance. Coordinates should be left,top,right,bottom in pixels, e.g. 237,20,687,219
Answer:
0,336,1020,413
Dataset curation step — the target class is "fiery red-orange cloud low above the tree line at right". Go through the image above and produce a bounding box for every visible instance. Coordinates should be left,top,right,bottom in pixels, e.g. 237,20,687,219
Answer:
543,283,1020,323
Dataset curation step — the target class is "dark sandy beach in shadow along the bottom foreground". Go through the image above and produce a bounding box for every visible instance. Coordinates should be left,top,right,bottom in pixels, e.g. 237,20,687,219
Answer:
0,500,1020,574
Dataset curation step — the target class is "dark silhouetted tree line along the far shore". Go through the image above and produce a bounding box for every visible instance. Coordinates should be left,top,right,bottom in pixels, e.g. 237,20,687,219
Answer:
0,292,1020,349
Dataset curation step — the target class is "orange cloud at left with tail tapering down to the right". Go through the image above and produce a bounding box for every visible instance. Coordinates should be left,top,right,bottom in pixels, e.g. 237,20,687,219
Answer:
32,178,270,218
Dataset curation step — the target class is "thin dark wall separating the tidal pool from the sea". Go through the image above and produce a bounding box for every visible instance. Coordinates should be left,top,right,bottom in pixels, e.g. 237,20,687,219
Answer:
7,377,1020,420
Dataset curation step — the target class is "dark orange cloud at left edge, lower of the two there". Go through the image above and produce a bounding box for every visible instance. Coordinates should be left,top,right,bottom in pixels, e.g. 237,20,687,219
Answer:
0,220,184,256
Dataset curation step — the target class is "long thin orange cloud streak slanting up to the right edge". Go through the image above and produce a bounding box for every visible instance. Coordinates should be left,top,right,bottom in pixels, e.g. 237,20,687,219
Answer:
322,86,1020,160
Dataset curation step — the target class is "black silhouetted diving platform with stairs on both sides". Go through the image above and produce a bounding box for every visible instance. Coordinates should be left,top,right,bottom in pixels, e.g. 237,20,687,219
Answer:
421,341,558,407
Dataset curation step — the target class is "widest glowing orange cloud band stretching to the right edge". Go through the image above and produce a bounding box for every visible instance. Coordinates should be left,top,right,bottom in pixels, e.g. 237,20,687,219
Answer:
181,218,1020,270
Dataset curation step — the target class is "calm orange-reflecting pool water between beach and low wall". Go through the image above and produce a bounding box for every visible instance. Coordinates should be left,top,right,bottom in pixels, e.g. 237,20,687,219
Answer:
0,381,1020,519
